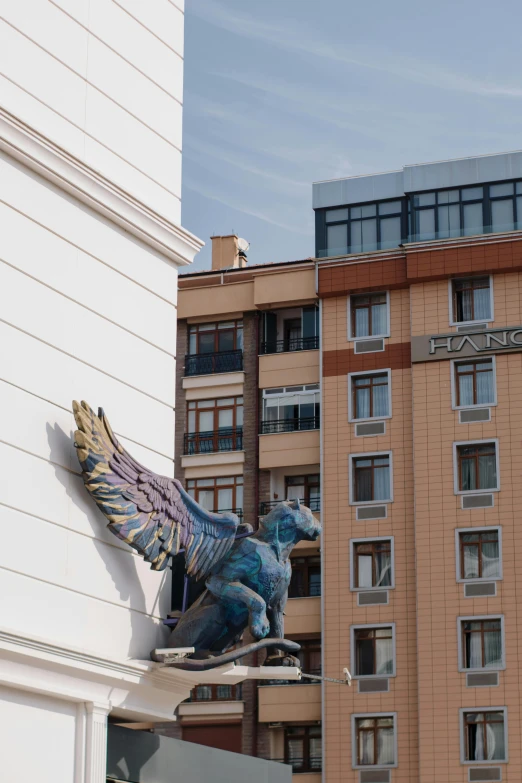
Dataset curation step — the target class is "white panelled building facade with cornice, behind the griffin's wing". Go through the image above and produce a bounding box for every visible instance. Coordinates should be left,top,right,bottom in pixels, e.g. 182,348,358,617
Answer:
0,0,202,783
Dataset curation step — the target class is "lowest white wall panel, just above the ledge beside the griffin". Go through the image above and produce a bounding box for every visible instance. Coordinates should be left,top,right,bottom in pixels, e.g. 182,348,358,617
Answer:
0,569,168,660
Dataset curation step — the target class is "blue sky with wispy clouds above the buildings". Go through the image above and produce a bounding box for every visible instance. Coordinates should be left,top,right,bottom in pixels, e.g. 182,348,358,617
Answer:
182,0,522,271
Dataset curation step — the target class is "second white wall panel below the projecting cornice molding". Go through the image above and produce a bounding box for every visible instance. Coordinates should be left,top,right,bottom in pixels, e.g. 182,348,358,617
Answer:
0,203,176,354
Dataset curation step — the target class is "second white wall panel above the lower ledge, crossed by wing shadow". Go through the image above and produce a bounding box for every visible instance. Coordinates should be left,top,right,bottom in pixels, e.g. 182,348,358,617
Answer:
0,506,170,620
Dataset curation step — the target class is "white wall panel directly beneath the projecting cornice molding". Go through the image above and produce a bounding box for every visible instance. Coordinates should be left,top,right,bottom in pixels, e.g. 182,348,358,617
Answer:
0,154,177,304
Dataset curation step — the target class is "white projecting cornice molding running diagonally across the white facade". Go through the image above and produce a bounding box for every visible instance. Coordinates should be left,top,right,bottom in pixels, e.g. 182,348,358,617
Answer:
0,107,204,266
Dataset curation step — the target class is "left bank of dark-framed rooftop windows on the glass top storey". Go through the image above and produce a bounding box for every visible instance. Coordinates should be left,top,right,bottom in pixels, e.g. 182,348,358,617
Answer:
317,200,406,257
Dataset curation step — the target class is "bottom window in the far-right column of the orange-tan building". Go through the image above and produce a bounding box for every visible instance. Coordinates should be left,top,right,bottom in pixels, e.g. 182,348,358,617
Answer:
461,707,507,762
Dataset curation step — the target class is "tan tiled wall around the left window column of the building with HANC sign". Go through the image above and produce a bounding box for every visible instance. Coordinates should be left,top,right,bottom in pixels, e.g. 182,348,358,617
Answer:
322,290,419,783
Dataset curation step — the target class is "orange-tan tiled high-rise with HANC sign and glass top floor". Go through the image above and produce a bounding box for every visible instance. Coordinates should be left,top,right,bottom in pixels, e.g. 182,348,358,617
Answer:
314,152,522,783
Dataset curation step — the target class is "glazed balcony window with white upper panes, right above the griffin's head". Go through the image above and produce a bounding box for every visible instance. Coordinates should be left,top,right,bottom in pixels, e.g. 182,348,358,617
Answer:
261,383,320,434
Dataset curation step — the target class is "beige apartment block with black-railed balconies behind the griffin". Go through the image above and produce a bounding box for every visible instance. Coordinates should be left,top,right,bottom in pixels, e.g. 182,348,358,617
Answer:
173,236,321,783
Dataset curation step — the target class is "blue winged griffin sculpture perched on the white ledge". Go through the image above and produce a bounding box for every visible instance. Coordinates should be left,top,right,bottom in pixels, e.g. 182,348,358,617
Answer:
73,402,321,669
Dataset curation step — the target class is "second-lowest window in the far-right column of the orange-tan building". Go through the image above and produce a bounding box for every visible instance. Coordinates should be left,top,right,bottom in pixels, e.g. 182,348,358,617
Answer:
458,617,504,670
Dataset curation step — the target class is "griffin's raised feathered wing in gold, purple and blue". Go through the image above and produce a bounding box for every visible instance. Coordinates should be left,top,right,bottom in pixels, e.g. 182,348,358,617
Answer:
73,402,239,579
